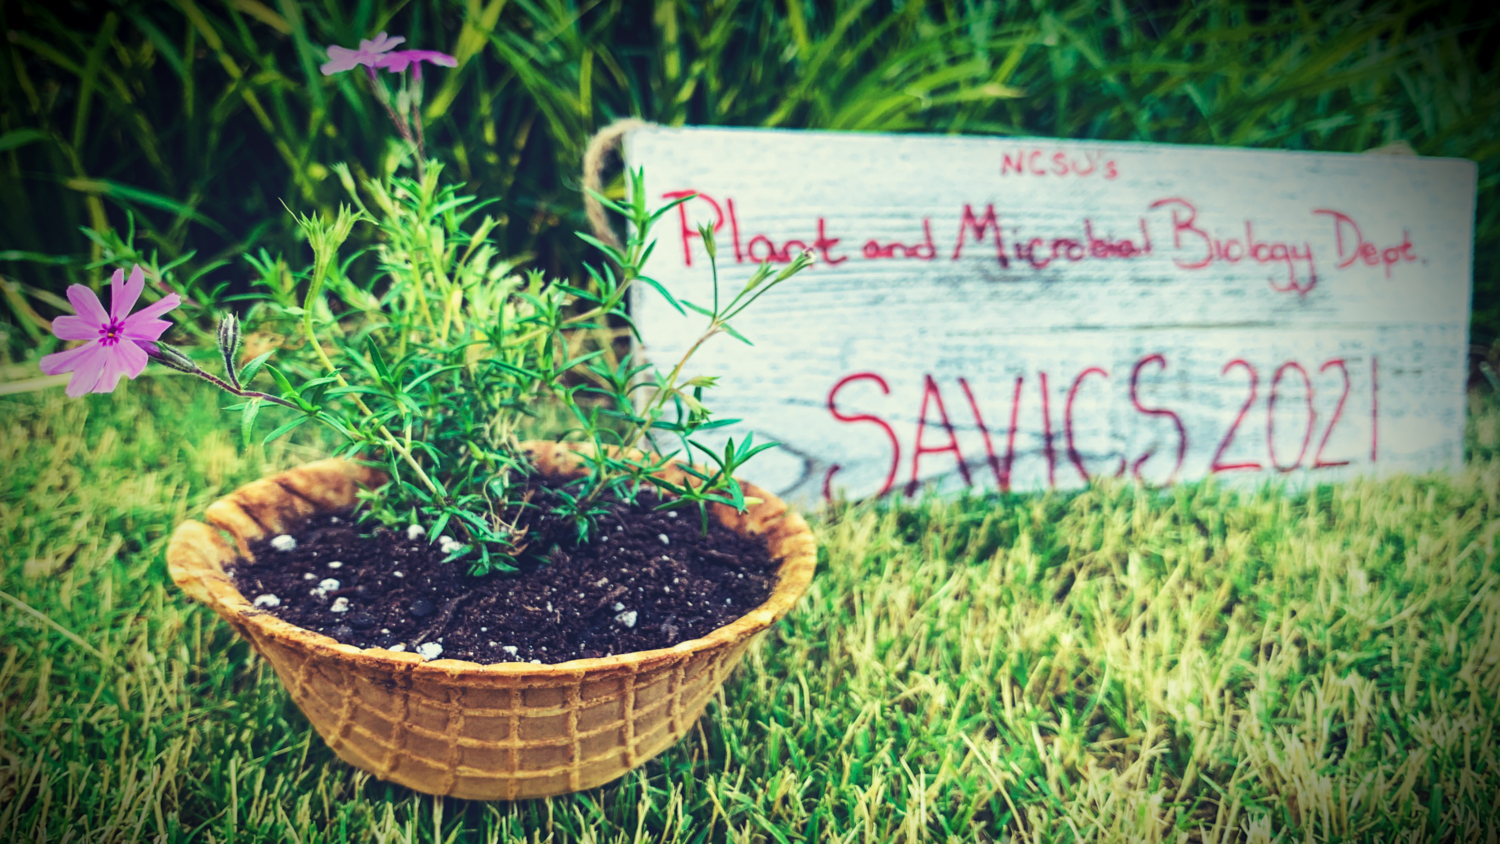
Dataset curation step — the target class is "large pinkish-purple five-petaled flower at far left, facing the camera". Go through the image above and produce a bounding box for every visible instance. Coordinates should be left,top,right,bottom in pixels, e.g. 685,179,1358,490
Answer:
42,265,182,397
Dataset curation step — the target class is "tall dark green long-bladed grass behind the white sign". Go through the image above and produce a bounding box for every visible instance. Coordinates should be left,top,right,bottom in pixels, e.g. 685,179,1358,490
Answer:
0,0,1500,353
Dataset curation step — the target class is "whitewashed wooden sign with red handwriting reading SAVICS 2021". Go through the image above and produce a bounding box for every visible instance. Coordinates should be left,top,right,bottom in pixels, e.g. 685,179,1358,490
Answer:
626,127,1476,504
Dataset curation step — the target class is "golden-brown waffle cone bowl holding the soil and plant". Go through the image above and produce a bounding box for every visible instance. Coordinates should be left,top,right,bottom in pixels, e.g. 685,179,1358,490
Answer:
167,442,816,801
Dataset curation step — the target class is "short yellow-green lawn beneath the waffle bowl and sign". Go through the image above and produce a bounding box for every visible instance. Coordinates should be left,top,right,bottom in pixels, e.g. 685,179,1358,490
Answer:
0,378,1500,844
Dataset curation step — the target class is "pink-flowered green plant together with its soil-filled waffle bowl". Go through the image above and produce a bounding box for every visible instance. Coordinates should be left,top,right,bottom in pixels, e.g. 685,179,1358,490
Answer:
42,33,816,799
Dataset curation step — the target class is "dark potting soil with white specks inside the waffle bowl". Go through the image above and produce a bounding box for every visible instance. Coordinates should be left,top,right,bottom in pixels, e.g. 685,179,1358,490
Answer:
230,487,779,664
